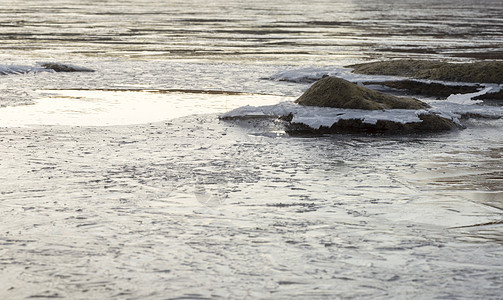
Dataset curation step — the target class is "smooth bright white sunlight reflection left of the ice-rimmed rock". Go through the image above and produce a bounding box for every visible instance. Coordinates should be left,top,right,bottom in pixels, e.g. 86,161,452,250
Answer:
0,90,293,127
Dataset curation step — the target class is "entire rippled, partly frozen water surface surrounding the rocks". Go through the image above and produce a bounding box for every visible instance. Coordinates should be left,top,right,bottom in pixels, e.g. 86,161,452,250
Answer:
0,0,503,299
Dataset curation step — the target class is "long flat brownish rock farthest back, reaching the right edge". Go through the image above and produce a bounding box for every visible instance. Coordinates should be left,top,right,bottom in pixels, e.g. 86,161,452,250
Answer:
348,60,503,83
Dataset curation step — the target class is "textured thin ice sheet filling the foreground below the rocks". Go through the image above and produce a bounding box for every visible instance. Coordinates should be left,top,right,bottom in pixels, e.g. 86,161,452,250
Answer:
0,92,503,299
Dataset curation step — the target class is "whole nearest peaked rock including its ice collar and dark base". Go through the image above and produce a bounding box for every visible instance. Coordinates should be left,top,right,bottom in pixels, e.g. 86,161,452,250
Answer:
221,77,461,134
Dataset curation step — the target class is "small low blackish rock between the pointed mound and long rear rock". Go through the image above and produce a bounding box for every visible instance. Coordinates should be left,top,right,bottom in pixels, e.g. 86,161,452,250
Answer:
364,80,480,98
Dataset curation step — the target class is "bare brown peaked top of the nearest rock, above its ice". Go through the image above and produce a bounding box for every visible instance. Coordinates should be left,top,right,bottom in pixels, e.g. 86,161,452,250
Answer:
295,77,429,110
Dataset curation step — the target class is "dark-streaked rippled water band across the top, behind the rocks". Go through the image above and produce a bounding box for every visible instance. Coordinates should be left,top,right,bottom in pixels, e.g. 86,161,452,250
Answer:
0,0,503,64
